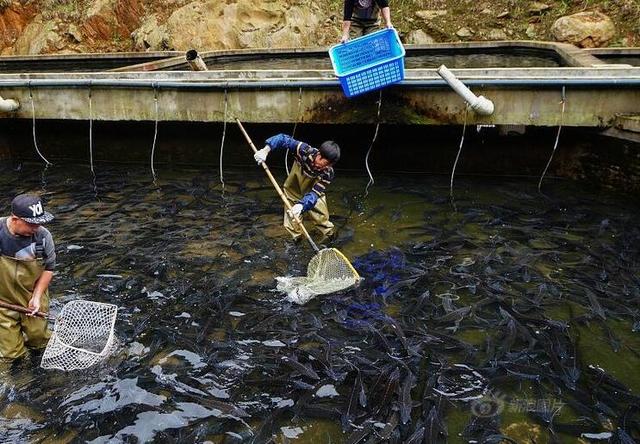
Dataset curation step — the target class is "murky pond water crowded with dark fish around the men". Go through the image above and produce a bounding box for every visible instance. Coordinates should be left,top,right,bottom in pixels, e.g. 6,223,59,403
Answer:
0,164,640,443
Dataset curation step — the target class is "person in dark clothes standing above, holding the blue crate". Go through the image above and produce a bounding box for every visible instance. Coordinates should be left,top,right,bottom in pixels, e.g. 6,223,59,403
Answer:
340,0,393,43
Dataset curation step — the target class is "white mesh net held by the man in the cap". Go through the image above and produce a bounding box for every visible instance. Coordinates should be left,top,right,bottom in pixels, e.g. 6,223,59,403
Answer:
40,301,118,371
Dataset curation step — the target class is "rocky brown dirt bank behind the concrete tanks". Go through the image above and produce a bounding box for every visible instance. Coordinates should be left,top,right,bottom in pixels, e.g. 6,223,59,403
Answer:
0,0,640,55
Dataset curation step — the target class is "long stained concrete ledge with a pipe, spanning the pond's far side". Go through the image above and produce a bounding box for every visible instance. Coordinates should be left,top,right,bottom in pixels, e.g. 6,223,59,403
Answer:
0,51,640,128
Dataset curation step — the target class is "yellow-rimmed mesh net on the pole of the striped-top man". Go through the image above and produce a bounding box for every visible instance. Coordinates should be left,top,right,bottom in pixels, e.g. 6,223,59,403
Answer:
276,248,360,304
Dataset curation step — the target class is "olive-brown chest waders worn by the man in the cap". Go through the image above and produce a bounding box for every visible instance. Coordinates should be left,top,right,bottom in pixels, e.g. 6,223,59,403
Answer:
0,256,51,358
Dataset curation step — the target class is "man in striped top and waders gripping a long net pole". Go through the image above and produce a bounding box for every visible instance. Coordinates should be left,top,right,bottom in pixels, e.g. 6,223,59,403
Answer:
254,134,340,240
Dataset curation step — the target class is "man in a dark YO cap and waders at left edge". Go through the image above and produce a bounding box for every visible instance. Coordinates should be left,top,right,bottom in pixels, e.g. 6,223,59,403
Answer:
0,194,56,359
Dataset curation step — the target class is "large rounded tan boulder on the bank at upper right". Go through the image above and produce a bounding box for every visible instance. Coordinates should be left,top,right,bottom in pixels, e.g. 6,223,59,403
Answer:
551,11,616,48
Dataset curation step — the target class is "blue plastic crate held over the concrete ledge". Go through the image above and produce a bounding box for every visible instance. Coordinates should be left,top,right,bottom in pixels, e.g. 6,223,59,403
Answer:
329,28,405,97
